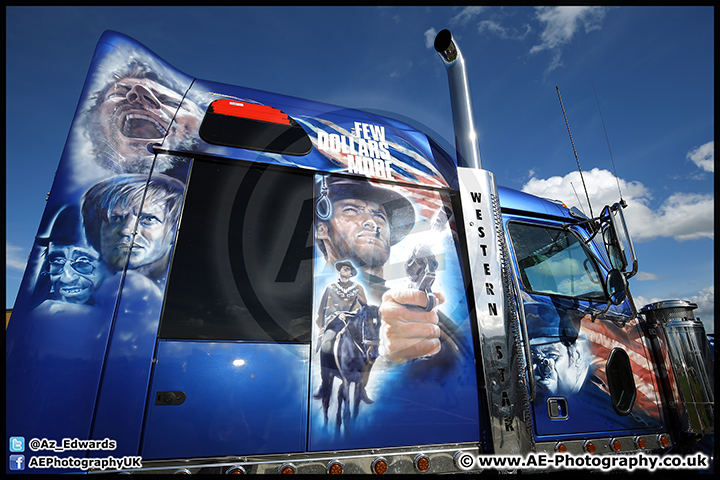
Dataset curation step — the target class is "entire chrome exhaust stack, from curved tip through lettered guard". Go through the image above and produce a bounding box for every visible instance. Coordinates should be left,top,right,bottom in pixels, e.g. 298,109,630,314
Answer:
444,30,535,455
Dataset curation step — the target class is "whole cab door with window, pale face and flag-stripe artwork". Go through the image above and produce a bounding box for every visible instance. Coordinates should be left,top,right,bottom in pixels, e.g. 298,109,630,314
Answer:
507,220,662,441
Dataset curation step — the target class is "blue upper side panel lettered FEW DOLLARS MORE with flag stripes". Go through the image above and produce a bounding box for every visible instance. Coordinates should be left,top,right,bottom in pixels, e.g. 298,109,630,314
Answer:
179,76,455,187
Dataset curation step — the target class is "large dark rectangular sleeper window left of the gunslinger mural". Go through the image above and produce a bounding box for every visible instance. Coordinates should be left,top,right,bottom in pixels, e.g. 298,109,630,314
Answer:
159,159,314,342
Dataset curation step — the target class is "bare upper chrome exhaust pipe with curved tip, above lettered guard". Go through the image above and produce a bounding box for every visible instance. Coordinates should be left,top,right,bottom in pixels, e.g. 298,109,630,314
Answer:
435,29,482,168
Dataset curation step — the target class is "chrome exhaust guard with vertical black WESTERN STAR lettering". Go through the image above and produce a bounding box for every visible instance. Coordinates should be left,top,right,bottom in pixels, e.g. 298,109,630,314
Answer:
458,167,533,455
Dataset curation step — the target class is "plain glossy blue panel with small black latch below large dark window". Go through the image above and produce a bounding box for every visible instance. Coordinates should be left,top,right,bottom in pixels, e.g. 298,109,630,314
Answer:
142,341,310,460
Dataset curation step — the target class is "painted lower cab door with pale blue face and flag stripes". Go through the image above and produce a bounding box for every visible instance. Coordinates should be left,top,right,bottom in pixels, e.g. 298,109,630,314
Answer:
522,293,662,437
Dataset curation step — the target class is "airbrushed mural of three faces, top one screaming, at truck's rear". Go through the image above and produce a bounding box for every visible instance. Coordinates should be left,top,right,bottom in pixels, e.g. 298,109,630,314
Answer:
25,36,202,315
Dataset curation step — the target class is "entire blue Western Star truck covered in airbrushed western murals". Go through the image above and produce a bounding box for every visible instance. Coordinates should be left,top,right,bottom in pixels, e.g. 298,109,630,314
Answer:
6,30,714,474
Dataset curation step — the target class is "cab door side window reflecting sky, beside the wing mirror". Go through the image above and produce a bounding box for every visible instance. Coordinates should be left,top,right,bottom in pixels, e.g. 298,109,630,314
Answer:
508,222,605,302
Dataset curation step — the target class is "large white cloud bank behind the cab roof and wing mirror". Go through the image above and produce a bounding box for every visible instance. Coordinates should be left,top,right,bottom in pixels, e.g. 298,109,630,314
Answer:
522,168,715,242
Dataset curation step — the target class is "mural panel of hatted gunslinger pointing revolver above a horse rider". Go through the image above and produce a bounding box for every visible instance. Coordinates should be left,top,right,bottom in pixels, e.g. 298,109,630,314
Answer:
310,175,479,449
